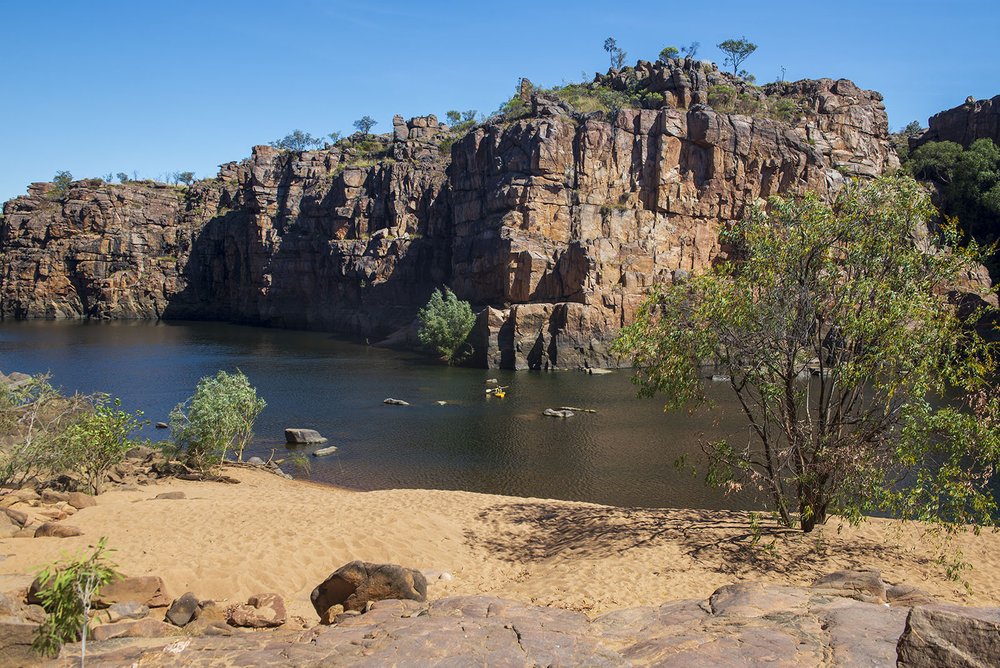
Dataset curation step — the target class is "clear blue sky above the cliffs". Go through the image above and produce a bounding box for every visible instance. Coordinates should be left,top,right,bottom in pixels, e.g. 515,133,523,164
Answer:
0,0,1000,201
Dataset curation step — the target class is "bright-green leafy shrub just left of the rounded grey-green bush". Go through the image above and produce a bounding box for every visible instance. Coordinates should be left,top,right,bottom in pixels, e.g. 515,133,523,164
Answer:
59,396,146,494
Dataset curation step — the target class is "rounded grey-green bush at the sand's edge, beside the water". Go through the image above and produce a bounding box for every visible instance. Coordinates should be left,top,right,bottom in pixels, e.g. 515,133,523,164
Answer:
170,369,267,469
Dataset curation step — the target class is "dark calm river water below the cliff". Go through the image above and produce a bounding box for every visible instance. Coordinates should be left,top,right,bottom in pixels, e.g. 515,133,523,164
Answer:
0,322,747,508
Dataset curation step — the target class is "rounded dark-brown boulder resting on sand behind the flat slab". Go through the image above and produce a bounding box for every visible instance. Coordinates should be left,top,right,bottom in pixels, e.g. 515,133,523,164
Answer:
310,561,427,624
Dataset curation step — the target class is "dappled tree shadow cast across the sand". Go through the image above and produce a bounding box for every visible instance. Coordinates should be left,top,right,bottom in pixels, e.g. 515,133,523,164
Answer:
466,502,932,577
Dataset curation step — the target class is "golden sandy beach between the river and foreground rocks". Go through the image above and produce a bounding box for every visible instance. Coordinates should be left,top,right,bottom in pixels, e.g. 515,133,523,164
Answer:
0,468,1000,624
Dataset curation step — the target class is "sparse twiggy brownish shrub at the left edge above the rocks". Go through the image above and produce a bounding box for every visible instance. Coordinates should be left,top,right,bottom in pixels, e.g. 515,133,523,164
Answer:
0,375,93,492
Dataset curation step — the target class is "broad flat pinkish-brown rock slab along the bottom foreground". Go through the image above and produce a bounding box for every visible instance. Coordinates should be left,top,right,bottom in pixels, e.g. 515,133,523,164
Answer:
76,584,944,668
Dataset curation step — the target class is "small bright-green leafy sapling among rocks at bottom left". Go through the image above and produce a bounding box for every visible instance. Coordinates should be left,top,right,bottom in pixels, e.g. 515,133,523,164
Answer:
32,537,120,664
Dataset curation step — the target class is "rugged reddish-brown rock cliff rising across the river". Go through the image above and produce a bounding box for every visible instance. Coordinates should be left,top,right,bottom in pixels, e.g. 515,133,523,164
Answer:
0,60,895,369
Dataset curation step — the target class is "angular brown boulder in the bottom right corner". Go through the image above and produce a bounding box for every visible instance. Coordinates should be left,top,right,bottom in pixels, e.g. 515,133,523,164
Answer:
896,605,1000,668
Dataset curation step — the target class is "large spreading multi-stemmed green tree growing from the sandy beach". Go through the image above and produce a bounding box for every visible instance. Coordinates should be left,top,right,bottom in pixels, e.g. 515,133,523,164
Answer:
616,176,1000,531
